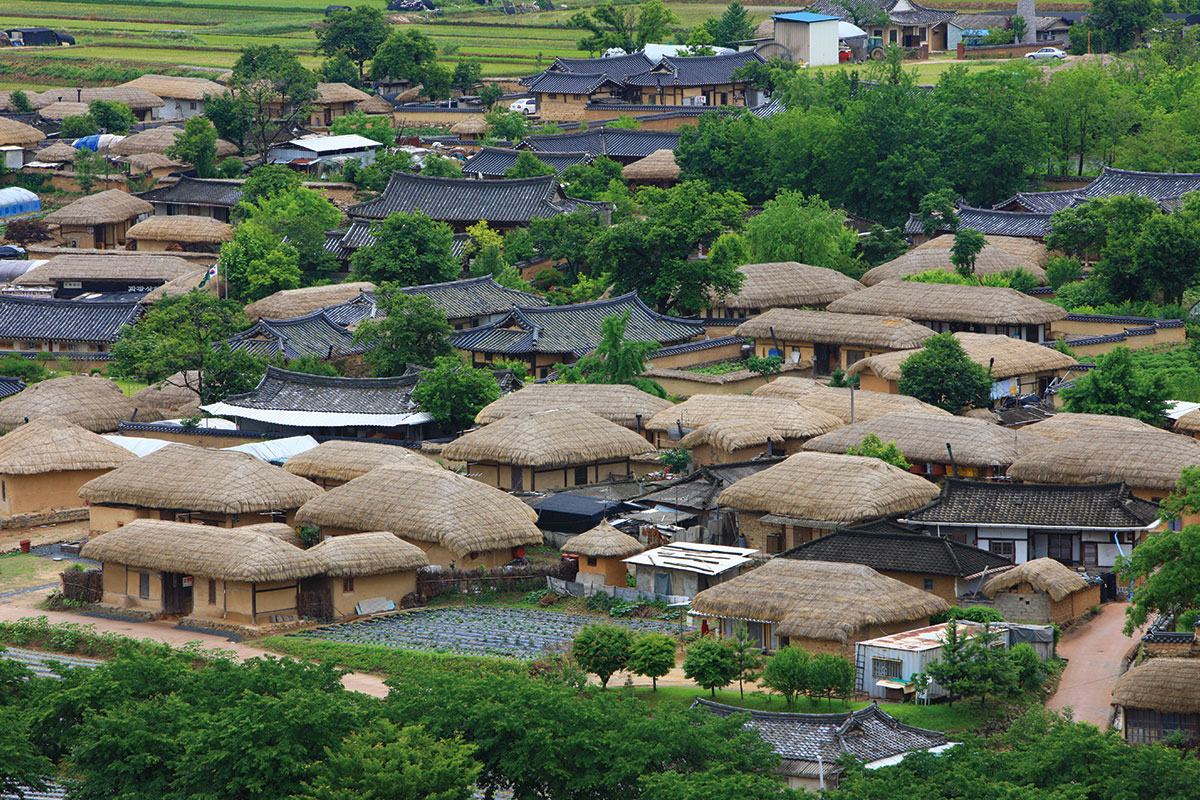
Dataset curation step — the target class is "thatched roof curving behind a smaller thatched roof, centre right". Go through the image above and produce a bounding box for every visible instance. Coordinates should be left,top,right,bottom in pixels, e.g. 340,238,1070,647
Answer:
646,395,841,439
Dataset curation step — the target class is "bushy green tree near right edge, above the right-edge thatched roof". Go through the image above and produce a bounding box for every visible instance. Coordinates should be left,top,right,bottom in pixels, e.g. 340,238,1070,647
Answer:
1060,344,1170,426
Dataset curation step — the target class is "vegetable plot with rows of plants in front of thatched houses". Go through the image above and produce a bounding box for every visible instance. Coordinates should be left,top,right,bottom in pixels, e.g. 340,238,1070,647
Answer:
287,607,679,660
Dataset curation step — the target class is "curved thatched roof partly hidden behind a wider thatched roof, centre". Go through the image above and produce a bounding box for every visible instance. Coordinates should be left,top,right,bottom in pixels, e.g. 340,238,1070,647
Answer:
475,384,671,431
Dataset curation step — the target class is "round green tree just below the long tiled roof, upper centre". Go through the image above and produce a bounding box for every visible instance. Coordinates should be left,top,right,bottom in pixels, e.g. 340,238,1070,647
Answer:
350,211,458,287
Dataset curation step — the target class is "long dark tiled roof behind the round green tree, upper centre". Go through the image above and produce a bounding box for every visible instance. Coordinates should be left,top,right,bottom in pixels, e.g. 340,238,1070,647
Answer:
347,172,595,224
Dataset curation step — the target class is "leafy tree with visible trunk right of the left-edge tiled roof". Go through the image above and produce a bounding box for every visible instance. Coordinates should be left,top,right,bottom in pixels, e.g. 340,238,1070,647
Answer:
109,289,248,403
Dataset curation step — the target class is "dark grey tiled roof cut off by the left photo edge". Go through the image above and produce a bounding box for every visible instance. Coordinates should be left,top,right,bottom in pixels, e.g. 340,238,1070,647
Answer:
0,295,142,344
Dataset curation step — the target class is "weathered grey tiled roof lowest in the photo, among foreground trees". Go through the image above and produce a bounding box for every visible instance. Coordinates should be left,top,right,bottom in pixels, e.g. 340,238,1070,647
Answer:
692,698,947,771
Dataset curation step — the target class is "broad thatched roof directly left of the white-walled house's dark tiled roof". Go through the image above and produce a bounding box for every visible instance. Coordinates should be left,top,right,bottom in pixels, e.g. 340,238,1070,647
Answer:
718,452,938,523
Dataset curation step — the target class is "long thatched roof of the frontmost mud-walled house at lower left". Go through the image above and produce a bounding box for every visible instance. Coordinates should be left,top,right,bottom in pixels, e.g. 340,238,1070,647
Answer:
82,520,322,583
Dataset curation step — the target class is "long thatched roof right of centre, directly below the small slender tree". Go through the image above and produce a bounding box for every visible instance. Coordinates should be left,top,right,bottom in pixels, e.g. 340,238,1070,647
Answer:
828,281,1067,325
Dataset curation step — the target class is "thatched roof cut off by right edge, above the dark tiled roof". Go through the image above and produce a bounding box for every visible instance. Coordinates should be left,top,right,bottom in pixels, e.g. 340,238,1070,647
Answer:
1008,426,1200,492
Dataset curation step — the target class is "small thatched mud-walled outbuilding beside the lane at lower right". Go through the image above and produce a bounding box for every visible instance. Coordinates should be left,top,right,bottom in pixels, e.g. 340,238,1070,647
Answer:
983,558,1100,625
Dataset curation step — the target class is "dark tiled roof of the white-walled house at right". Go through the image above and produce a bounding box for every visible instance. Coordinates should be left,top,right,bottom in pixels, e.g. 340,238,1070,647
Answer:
906,479,1158,530
